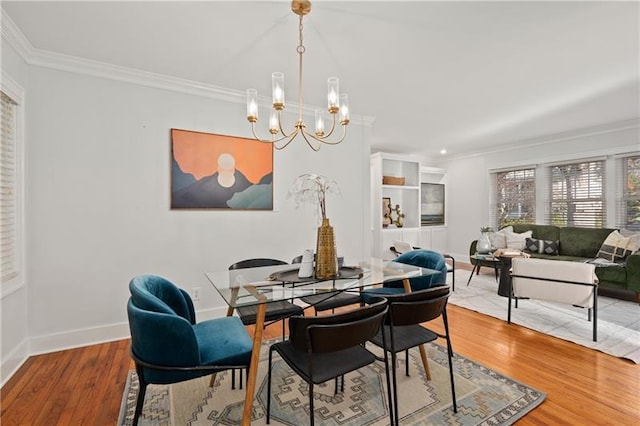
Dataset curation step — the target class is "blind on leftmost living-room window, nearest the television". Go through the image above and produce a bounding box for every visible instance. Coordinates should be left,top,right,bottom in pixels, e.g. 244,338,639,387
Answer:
490,168,536,229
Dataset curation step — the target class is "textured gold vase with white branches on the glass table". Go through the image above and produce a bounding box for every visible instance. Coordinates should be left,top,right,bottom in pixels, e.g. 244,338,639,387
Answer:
287,174,340,279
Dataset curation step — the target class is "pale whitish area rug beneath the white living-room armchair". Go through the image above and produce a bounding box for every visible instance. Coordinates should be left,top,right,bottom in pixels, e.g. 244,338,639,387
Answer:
449,270,640,364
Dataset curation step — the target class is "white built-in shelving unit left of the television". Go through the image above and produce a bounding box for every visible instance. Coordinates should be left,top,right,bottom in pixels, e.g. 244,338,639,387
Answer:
371,153,420,259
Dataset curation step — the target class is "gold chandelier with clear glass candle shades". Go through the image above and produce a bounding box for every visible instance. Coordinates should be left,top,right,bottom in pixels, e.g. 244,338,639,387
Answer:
247,0,349,151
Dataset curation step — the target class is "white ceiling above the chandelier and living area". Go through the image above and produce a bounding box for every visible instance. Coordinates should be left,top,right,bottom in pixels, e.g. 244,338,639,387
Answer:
2,0,640,160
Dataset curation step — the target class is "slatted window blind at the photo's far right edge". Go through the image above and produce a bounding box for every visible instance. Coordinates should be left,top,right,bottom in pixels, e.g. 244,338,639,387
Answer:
616,155,640,231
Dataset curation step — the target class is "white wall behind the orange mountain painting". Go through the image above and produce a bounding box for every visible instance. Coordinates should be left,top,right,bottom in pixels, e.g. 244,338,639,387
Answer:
2,40,370,381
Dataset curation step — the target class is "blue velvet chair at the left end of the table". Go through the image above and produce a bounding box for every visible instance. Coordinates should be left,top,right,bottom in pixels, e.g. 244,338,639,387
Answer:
127,275,253,424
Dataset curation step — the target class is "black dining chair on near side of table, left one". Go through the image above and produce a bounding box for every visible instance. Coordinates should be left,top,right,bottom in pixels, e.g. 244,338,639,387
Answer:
267,299,393,426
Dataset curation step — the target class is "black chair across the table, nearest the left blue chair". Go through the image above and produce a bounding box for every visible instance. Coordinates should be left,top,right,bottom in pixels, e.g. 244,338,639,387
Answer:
229,257,304,389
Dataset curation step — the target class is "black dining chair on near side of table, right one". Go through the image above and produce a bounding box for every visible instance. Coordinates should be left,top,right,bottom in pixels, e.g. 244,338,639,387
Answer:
371,286,458,425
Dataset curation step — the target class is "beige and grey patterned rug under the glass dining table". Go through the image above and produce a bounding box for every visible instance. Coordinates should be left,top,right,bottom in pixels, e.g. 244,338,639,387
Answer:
118,342,546,426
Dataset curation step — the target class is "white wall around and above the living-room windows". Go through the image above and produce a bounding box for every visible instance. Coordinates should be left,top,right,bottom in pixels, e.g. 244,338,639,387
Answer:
440,121,640,262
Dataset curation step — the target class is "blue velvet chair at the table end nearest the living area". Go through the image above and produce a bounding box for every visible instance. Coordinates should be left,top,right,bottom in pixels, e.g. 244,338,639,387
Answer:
362,249,447,303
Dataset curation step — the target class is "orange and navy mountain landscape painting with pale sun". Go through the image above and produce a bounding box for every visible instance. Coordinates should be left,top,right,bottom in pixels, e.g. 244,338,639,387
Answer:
170,128,273,211
